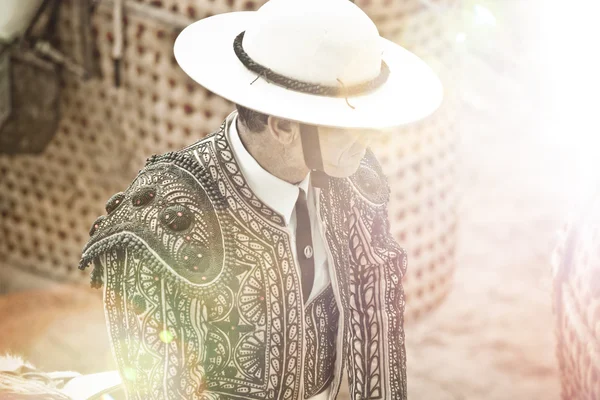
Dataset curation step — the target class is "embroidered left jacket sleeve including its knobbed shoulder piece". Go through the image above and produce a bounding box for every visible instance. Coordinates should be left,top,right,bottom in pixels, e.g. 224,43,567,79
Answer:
80,152,222,400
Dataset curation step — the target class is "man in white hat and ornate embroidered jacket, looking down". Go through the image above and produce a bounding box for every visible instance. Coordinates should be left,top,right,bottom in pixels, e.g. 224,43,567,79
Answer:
80,0,441,400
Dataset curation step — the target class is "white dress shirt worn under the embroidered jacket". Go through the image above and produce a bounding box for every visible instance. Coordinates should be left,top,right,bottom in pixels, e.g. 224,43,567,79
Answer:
227,114,330,400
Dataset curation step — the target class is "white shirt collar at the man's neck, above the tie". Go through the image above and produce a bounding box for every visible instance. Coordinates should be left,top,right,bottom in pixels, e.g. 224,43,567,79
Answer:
227,113,310,225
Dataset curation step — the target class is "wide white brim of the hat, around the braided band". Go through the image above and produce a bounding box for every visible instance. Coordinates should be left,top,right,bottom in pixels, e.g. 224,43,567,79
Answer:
174,11,443,129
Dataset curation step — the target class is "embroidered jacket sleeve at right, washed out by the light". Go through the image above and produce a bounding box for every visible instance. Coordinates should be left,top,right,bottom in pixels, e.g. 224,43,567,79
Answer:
345,153,407,400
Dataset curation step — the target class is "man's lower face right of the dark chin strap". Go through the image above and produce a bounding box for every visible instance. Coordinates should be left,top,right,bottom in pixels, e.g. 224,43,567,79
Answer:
319,126,378,178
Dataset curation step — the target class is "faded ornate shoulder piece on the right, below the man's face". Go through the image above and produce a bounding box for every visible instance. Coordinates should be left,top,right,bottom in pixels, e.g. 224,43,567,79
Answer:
349,149,390,205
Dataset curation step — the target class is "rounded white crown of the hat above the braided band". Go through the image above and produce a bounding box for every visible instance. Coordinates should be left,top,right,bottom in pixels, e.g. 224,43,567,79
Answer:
243,0,382,86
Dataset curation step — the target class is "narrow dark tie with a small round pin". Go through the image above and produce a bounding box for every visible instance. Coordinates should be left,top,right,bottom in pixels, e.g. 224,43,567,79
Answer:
296,189,315,304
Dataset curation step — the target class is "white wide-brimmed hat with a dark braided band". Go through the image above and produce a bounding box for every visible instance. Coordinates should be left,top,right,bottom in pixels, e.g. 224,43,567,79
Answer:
174,0,443,129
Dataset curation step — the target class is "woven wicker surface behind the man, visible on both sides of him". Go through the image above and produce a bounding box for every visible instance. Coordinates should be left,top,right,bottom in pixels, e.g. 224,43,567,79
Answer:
0,0,460,318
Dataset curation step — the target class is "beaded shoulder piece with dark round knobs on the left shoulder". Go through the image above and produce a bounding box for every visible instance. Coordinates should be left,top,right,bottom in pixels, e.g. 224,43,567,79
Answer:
79,152,225,288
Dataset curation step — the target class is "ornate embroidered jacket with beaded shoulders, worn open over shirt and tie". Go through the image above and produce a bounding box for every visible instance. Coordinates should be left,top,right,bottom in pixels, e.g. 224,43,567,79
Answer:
80,114,406,400
